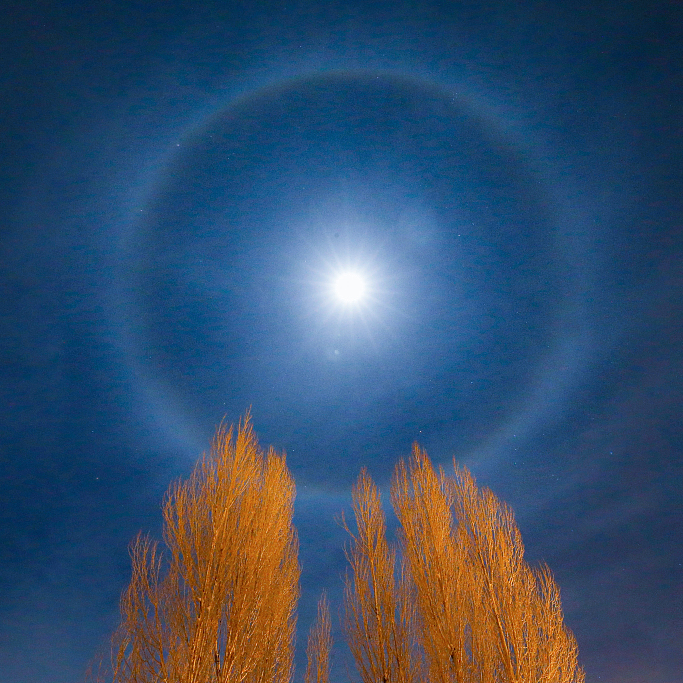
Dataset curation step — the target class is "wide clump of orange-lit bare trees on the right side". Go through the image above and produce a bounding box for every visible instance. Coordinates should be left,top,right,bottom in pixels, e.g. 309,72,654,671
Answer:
345,445,584,683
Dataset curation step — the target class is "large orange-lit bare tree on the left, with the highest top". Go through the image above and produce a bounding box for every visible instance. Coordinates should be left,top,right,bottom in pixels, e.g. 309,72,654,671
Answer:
98,415,300,683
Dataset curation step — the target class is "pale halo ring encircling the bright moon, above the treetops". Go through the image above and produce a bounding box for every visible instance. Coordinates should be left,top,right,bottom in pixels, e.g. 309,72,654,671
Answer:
111,67,588,478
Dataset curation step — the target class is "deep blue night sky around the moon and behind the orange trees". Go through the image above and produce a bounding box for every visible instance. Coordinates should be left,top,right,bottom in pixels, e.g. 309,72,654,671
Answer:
0,0,683,683
